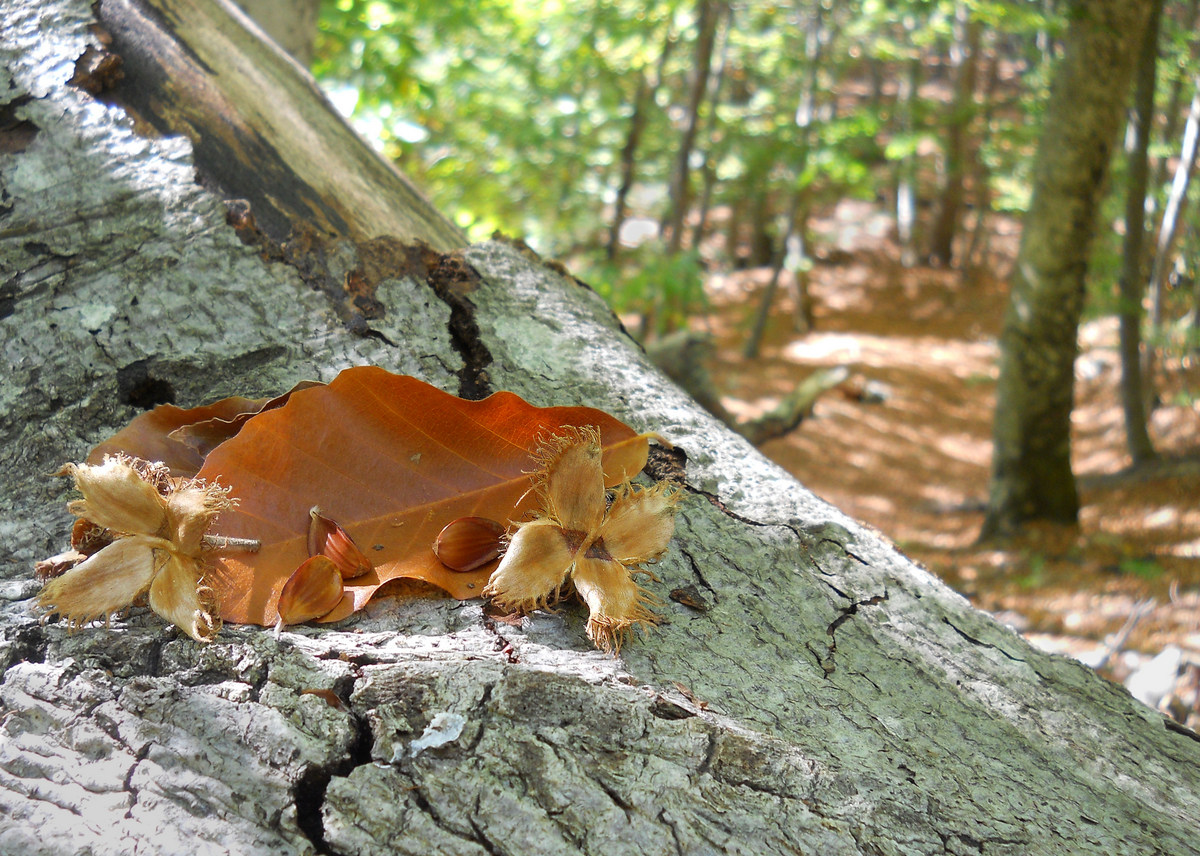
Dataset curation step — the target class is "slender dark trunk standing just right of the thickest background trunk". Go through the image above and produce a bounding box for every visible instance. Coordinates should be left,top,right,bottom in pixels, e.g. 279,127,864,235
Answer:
1117,0,1163,463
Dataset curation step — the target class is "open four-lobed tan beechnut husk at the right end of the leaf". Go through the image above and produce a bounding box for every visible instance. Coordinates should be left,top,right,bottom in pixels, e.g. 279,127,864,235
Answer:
484,427,679,652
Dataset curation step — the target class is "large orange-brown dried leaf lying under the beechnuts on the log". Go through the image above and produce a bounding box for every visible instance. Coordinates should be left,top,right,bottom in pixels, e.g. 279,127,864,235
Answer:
190,366,649,625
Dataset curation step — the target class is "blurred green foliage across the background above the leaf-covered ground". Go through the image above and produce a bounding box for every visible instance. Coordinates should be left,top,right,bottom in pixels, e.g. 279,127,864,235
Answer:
314,0,1198,364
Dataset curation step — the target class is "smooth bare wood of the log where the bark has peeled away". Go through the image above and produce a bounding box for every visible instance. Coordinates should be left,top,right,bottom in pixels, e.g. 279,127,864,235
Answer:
88,0,464,250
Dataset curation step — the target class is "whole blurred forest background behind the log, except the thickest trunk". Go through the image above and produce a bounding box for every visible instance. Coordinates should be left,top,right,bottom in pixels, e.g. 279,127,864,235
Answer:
255,0,1200,728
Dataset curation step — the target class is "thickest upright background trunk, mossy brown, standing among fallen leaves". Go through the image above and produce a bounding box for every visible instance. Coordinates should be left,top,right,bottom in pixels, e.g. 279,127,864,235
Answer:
983,0,1152,537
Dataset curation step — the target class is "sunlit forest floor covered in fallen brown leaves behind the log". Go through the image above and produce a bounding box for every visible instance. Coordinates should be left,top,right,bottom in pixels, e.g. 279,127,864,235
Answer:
696,203,1200,728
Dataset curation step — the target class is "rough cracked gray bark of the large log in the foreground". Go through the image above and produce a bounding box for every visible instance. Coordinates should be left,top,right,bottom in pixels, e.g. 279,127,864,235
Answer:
0,0,1200,856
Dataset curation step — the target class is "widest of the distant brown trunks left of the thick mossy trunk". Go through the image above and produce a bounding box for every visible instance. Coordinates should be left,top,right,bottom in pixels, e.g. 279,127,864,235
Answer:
929,2,983,267
